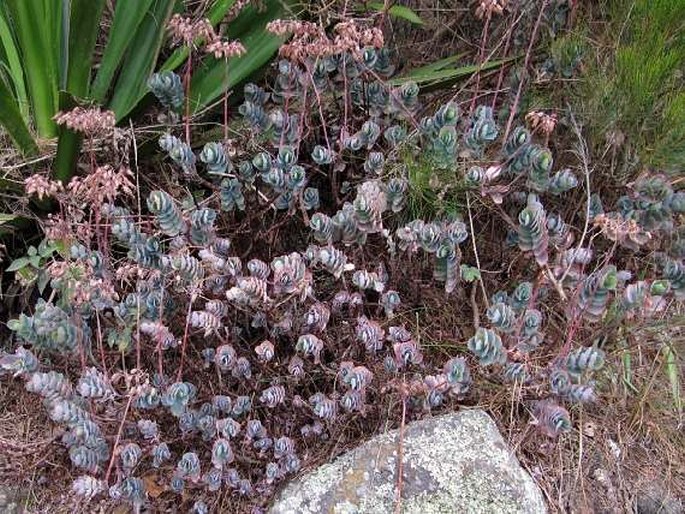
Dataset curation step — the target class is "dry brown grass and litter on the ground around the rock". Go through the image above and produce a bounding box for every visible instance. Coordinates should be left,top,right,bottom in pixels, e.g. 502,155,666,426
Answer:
0,280,685,513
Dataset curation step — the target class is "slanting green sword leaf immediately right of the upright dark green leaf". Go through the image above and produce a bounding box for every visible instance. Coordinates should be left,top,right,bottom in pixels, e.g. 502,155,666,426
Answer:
91,0,153,103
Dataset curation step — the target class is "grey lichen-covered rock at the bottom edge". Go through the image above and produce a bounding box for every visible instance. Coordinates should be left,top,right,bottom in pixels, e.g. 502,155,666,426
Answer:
270,410,546,514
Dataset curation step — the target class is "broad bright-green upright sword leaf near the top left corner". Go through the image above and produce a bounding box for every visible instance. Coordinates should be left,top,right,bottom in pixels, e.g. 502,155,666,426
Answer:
6,0,62,138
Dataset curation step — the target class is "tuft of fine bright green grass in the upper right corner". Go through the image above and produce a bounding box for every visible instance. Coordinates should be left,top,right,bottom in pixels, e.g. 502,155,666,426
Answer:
582,0,685,173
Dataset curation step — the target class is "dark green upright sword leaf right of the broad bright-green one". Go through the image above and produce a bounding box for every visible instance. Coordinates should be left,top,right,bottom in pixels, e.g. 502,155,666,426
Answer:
66,0,105,98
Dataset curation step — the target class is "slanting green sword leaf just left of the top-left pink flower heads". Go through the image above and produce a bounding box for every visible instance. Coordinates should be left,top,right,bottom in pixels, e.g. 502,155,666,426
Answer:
109,0,174,120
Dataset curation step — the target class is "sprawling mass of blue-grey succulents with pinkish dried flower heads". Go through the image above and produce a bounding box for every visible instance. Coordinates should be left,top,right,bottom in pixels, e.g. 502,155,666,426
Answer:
0,2,685,512
